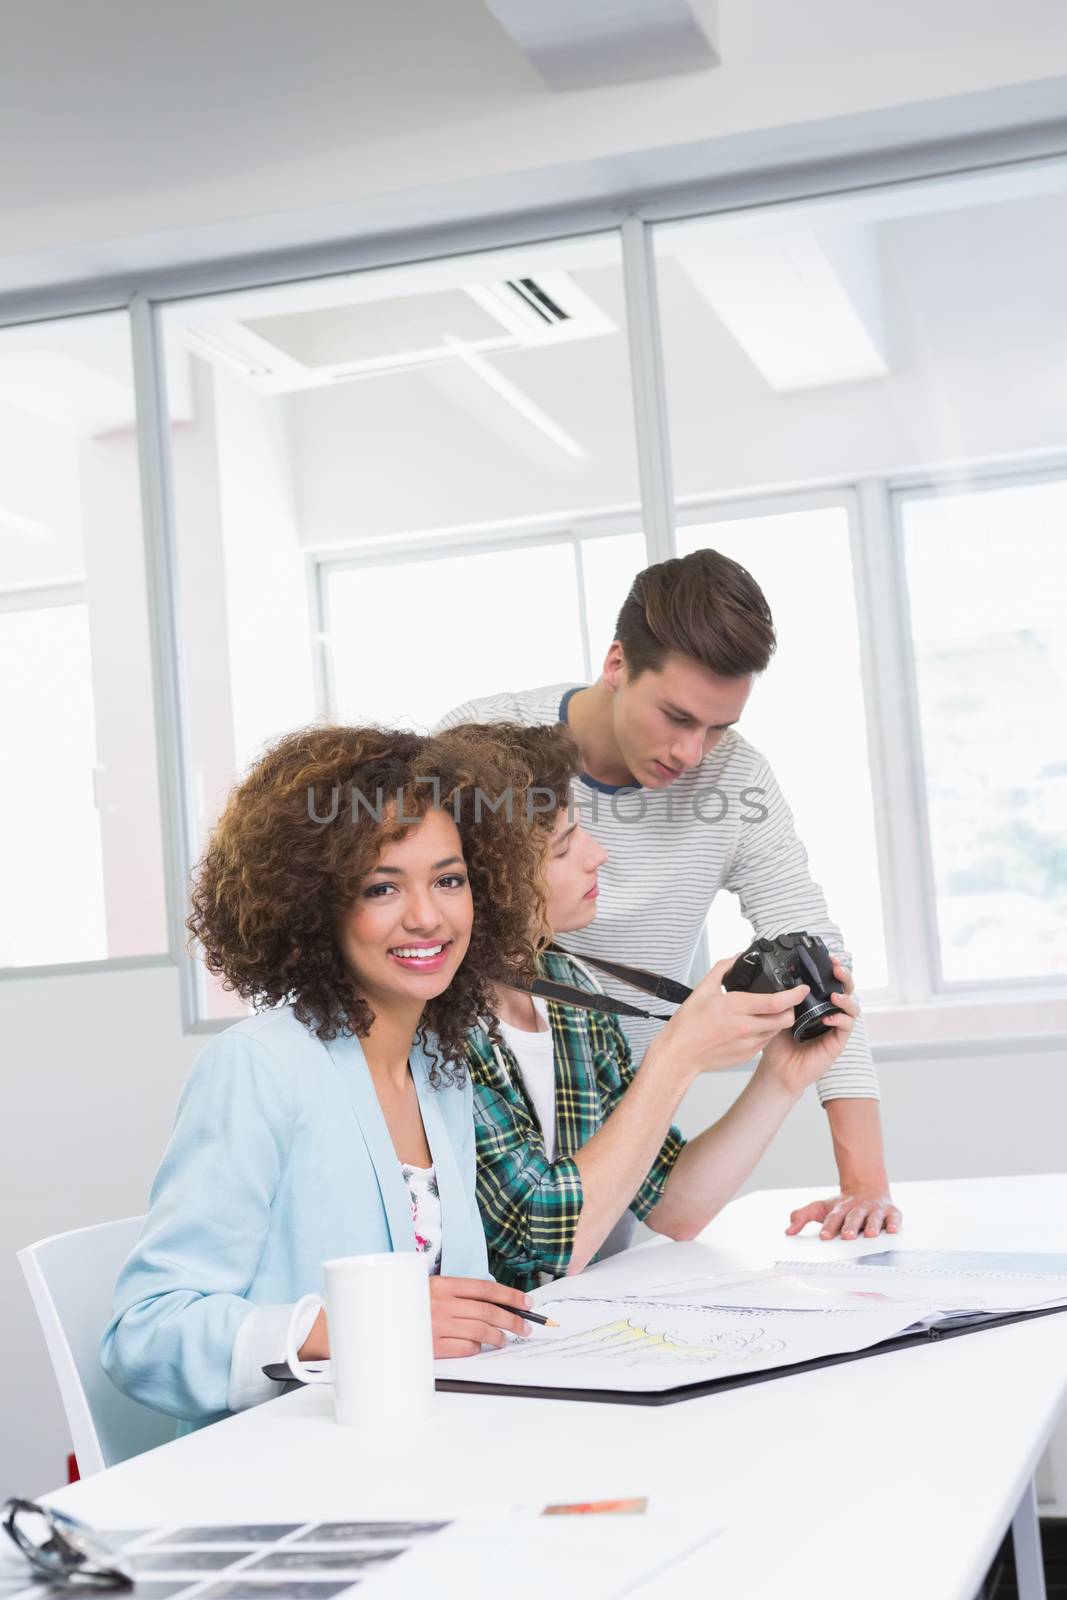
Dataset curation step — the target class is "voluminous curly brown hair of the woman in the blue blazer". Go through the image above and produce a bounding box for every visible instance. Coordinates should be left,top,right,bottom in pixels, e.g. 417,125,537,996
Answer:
187,726,545,1083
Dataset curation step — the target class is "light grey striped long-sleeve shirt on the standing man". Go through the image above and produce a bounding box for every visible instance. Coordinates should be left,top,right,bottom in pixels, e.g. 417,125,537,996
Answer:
438,683,878,1102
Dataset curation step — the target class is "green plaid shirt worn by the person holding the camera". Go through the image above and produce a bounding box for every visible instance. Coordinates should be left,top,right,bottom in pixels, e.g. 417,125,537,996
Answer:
467,954,685,1290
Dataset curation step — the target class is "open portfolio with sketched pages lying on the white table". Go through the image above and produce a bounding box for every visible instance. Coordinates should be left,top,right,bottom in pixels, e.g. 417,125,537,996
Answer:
437,1245,1067,1405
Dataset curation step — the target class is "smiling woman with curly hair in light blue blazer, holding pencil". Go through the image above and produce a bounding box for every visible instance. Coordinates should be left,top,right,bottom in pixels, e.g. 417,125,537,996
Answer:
101,726,544,1426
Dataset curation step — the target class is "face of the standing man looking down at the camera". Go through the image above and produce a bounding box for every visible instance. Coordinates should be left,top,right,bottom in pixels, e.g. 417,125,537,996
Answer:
603,642,752,789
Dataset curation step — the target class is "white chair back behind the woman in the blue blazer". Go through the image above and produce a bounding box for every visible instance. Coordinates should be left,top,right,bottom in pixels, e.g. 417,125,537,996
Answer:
18,1216,174,1478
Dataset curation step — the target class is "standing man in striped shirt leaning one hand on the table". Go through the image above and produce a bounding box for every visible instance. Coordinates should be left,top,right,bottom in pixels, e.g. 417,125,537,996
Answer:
440,550,901,1238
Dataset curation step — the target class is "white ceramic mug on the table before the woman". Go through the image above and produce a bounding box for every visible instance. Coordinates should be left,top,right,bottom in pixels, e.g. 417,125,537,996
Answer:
285,1250,434,1427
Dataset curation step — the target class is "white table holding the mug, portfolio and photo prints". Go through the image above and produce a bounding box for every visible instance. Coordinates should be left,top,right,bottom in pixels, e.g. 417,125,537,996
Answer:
51,1176,1067,1600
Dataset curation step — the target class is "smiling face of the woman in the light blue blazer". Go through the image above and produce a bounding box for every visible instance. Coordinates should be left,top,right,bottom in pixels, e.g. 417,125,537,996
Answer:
338,811,474,1010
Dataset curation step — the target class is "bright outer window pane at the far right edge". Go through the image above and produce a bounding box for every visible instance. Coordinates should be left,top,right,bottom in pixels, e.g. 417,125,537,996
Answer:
899,478,1067,982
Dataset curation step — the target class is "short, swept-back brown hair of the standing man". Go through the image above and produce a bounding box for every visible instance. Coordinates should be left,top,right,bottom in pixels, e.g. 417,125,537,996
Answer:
614,550,774,678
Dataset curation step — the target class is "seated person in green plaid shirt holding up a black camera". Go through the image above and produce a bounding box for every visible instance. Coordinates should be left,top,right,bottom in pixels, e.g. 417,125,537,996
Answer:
464,723,859,1290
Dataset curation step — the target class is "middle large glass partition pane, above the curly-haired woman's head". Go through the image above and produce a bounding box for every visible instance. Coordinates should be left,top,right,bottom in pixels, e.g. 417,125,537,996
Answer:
163,234,641,1018
